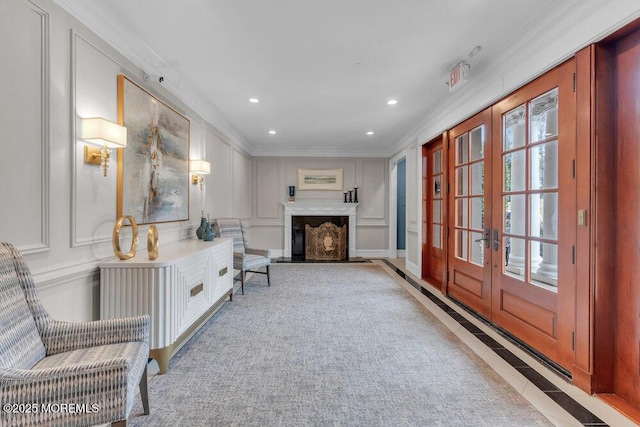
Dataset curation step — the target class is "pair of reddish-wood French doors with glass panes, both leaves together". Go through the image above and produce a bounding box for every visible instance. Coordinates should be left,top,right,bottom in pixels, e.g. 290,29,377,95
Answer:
447,60,577,369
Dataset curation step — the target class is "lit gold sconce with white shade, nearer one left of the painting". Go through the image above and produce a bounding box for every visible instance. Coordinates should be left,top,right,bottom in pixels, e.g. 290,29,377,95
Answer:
82,117,127,176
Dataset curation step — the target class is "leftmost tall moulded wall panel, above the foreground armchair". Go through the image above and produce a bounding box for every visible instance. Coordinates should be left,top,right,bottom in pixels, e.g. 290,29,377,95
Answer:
0,1,51,254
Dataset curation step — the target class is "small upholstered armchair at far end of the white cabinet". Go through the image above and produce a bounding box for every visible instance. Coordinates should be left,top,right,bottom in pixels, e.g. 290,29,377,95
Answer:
213,218,271,295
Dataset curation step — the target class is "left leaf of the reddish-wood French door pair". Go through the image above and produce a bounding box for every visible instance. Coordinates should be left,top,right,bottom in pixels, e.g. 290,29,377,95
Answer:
447,109,492,318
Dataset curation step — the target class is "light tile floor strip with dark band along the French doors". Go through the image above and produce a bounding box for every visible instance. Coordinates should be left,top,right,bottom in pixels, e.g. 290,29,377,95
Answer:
374,258,637,427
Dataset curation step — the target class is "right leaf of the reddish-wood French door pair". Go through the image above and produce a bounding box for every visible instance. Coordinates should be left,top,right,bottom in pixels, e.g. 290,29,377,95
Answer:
490,60,577,370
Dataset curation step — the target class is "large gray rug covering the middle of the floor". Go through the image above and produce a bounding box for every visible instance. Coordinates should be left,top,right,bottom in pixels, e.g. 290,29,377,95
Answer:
129,264,551,426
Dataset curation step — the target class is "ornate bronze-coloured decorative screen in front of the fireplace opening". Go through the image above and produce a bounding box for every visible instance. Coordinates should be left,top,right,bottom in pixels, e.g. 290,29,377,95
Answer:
304,222,347,261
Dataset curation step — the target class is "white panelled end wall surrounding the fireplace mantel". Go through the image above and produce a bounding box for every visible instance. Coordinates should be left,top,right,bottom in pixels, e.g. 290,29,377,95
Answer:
249,157,389,257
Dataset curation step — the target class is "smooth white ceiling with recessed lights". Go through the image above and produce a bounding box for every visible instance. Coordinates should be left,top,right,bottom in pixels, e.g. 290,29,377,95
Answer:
55,0,560,156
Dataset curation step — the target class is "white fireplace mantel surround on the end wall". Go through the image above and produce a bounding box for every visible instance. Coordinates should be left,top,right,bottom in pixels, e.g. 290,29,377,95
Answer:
282,202,358,258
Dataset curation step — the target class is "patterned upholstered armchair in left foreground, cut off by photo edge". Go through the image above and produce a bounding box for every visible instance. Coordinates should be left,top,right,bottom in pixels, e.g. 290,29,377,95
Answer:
0,243,149,426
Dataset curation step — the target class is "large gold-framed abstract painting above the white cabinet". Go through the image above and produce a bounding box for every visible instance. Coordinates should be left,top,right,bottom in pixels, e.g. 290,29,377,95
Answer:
116,75,190,224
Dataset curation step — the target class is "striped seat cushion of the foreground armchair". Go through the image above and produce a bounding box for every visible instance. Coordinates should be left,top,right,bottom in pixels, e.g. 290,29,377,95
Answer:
31,341,149,413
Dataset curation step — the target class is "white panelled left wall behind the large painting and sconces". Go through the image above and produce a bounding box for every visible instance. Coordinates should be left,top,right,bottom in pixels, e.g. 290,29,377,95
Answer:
0,0,251,321
